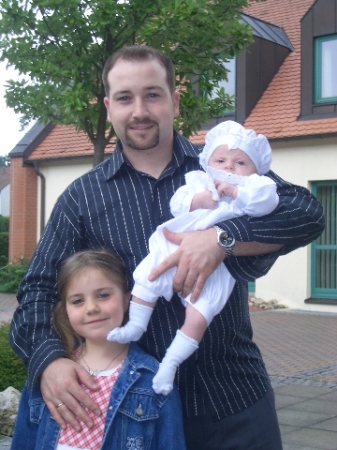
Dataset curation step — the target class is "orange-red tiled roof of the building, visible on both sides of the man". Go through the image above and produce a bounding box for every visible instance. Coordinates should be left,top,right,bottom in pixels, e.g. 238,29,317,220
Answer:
29,0,337,160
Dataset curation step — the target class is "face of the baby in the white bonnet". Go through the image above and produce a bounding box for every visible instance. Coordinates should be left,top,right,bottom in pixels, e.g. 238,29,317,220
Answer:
208,145,257,175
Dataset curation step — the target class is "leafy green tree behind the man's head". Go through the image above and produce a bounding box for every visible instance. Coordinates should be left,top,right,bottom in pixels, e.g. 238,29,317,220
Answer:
0,0,258,165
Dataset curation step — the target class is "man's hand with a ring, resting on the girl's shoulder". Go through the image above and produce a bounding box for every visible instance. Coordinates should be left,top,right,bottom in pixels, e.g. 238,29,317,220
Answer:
40,358,101,431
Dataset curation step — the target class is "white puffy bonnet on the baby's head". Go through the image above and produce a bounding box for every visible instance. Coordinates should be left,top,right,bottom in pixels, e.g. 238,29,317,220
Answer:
199,120,271,175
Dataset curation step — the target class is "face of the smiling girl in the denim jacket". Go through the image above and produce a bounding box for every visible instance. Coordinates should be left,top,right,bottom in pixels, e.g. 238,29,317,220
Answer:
66,268,130,342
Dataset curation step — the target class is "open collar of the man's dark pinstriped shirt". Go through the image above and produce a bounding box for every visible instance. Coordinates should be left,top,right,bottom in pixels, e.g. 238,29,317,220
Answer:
103,130,202,179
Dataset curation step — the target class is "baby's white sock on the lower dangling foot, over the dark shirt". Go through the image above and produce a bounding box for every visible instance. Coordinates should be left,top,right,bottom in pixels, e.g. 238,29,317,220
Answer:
152,330,199,395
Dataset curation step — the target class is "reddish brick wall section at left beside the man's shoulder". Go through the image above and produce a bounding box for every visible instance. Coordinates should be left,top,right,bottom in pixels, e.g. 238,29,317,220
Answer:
8,157,37,262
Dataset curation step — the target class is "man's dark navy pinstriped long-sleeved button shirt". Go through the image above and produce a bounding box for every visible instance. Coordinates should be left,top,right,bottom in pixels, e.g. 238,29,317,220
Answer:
10,133,324,420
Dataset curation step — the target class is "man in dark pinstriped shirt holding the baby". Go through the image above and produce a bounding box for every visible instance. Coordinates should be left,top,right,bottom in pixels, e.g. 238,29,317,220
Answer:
11,46,324,450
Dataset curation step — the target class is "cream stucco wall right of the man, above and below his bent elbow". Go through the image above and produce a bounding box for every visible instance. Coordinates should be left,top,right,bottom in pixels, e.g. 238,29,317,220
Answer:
256,138,337,313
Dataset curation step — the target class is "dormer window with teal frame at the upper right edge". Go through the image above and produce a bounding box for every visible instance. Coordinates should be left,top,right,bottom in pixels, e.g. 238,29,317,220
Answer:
315,34,337,103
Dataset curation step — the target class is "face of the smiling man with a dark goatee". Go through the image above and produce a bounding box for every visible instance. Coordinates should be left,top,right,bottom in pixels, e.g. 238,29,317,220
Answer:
104,59,179,151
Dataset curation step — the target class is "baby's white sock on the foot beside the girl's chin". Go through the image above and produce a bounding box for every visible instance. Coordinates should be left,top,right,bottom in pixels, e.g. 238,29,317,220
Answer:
107,301,153,344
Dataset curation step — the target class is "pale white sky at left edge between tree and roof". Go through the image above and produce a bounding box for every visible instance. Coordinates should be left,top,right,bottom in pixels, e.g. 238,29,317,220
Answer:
0,62,31,155
